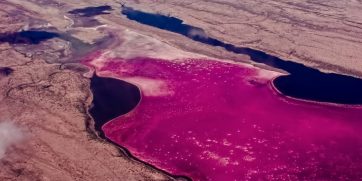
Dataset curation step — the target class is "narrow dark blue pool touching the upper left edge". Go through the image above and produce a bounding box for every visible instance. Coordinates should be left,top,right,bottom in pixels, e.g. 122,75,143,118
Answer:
0,30,59,44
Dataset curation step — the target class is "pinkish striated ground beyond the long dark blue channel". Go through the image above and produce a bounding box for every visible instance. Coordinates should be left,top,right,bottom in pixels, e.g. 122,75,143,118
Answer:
124,0,362,76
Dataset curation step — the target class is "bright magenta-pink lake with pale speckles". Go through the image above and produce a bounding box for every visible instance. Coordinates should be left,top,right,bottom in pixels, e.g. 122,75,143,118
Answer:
87,58,362,181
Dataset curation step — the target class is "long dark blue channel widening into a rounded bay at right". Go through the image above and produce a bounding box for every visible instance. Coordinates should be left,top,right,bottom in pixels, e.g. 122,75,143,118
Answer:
122,6,362,104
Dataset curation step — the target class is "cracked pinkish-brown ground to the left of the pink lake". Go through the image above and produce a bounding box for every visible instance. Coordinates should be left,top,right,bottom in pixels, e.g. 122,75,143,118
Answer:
0,3,172,181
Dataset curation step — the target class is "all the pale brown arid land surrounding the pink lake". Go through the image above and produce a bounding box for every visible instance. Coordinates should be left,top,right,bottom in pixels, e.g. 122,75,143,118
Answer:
0,0,362,181
